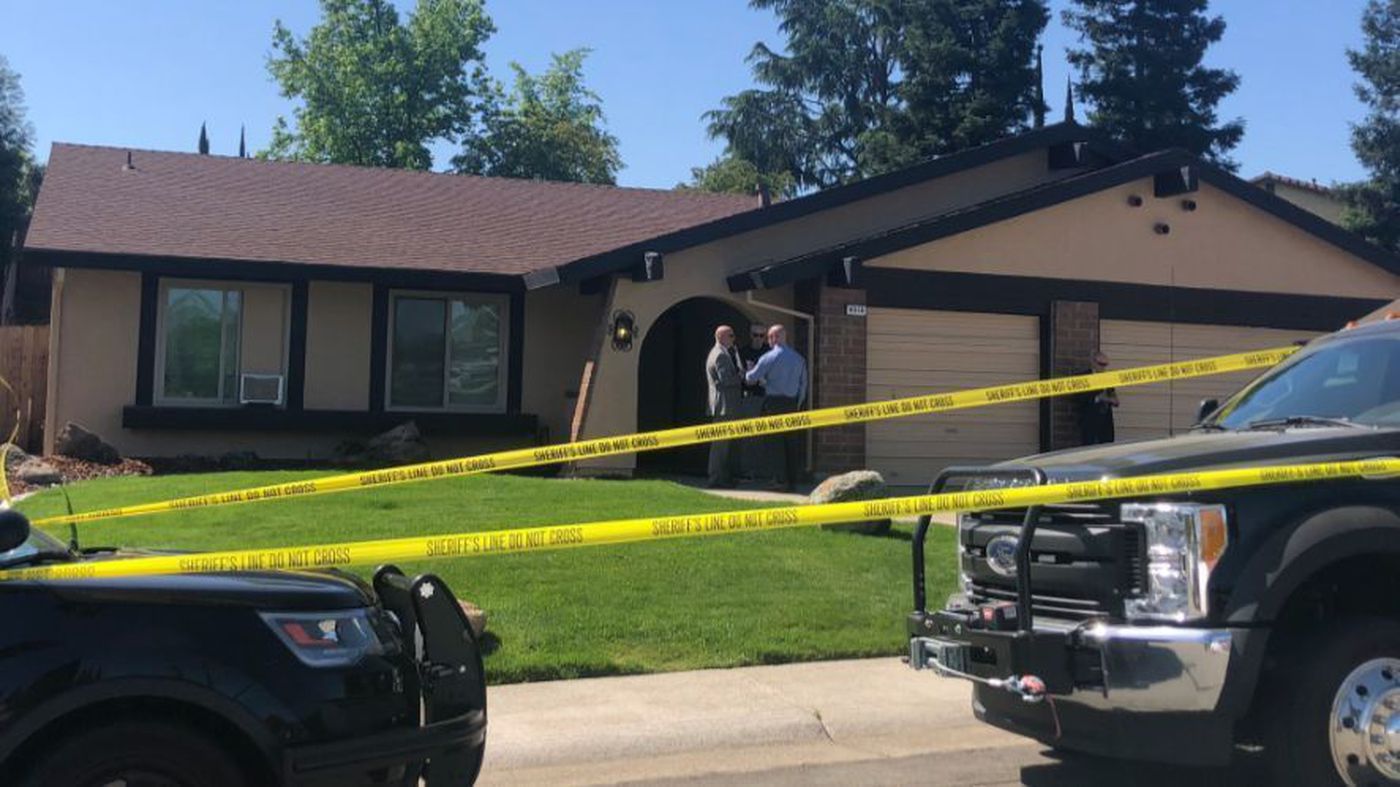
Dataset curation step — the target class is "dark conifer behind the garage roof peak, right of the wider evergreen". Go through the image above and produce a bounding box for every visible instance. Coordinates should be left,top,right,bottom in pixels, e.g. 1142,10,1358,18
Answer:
1064,0,1245,169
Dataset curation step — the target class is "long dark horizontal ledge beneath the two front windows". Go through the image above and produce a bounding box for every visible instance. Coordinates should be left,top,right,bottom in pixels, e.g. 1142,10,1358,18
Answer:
122,405,539,438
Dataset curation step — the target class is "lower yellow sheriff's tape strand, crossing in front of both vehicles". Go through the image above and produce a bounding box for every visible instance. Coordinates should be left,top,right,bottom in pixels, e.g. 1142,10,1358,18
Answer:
8,458,1400,581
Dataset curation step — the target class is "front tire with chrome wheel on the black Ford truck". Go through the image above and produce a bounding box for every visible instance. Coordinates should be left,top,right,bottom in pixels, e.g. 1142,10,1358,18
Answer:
1263,616,1400,786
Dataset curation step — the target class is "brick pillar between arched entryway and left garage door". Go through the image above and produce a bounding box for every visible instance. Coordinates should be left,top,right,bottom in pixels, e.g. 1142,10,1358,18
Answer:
812,283,865,473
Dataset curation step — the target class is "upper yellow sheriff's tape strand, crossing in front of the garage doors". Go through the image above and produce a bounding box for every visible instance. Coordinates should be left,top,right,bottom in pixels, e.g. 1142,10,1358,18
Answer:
34,347,1298,527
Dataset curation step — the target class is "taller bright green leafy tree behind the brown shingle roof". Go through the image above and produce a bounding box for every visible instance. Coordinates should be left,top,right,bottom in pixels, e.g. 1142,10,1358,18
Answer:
260,0,496,169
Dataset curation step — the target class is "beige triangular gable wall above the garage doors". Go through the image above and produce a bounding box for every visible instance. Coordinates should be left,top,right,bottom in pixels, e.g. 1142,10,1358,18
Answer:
867,179,1400,298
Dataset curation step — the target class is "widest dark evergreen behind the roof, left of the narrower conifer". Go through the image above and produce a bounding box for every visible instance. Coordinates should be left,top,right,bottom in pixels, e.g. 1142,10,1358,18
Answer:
706,0,1049,189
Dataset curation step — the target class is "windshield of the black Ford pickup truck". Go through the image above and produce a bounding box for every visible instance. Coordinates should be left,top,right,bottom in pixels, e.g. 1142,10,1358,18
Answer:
1207,335,1400,429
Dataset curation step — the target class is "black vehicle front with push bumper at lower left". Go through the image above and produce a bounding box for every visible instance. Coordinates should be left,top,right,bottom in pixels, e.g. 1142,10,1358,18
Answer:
0,511,486,787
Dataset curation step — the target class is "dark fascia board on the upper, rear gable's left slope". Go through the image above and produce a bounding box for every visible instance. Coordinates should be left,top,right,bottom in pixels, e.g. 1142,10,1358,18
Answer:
525,122,1134,288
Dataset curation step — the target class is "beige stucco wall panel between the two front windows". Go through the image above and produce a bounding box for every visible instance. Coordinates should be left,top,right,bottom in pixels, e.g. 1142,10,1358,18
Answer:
302,281,374,410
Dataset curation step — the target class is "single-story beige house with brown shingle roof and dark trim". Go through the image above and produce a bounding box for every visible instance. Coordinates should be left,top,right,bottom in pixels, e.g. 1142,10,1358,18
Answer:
24,123,1400,485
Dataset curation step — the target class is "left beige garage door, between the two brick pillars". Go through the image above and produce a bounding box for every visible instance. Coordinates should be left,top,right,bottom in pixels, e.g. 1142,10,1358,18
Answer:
865,307,1040,486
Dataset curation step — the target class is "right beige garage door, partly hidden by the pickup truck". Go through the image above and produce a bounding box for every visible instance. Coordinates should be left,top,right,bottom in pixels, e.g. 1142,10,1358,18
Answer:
1099,319,1317,441
